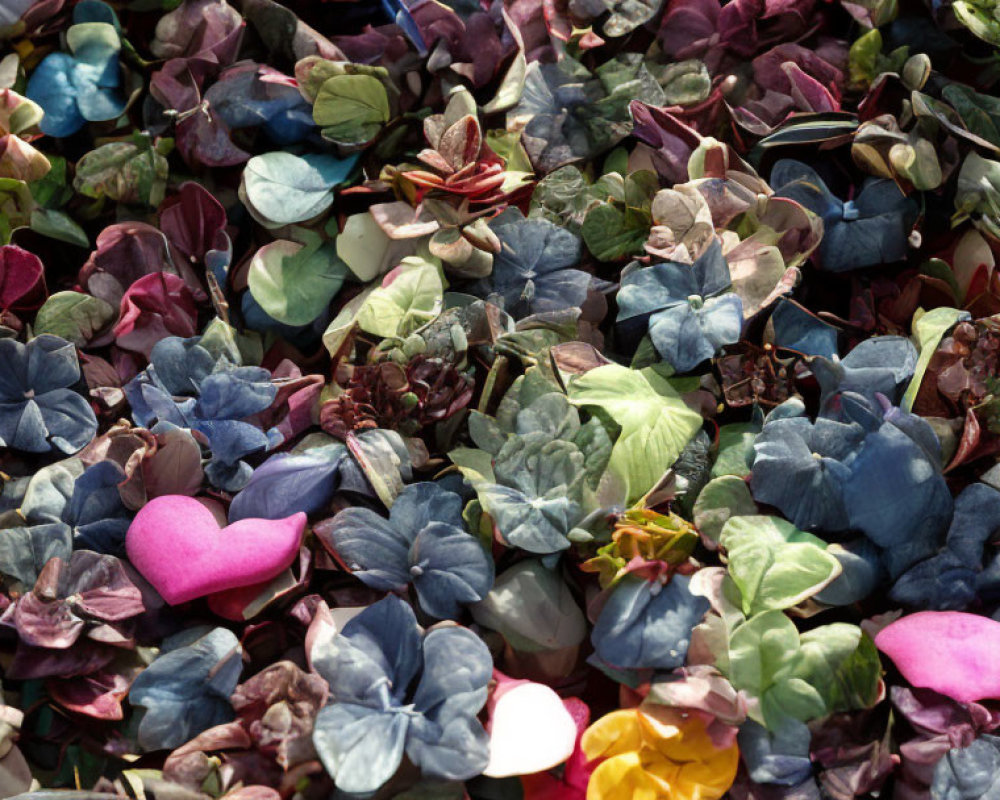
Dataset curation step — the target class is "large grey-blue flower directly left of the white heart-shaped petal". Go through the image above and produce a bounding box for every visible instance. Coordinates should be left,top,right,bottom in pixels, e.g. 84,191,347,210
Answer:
310,595,493,793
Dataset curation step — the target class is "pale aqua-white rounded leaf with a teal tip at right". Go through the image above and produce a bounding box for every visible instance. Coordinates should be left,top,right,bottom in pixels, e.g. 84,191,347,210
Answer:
240,152,357,227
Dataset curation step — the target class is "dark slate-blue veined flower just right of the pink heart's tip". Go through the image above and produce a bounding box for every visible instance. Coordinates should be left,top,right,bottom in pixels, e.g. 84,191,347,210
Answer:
315,482,493,619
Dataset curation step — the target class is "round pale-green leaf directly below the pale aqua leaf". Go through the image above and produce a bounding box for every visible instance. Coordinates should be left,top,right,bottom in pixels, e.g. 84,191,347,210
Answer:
247,239,349,325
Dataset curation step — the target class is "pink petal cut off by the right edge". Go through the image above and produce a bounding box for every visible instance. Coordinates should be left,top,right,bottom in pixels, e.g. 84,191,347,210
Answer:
875,611,1000,703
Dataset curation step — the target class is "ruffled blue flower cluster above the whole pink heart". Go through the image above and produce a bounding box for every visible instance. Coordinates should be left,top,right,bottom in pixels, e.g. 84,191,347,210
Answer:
125,336,278,491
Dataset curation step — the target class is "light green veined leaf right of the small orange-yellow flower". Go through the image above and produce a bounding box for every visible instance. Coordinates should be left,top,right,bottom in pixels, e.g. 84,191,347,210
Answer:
719,516,841,616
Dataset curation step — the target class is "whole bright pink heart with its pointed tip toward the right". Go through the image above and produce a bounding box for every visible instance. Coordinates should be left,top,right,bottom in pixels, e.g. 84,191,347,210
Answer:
125,495,306,605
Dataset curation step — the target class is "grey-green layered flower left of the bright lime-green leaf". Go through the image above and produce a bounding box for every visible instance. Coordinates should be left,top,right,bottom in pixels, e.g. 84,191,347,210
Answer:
450,371,611,553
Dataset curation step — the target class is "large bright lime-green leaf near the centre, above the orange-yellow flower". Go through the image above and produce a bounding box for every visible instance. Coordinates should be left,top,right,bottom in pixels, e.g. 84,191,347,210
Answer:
569,364,702,502
